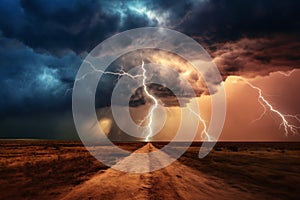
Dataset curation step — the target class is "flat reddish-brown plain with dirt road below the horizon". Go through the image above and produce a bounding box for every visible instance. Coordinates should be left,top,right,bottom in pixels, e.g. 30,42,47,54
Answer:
0,140,300,199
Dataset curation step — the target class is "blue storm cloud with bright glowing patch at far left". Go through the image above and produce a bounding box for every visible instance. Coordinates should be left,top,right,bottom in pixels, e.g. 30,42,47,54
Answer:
0,37,81,118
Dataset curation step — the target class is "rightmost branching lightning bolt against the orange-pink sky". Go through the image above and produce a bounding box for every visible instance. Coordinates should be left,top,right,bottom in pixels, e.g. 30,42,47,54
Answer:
239,76,300,136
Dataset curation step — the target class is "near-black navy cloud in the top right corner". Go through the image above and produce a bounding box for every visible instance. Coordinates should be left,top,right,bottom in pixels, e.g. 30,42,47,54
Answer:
177,0,300,41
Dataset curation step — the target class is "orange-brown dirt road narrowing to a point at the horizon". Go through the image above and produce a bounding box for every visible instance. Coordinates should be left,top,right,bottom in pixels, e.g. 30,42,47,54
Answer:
61,143,259,200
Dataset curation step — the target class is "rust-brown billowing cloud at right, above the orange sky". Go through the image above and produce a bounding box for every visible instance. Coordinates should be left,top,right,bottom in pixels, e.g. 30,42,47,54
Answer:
212,35,300,78
